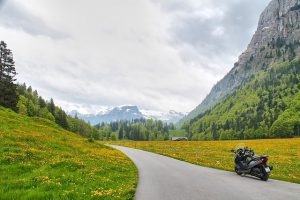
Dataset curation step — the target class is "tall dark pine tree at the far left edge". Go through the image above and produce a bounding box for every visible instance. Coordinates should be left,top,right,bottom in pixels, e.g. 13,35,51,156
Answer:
0,41,19,110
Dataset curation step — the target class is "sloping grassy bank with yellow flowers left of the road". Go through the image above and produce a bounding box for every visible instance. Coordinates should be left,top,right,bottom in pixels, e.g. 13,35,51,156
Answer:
0,107,137,200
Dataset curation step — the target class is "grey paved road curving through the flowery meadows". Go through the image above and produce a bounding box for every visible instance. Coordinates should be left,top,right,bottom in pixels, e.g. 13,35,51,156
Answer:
113,146,300,200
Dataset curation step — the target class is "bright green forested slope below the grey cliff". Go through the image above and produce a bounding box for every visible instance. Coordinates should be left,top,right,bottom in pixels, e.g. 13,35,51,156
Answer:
185,58,300,140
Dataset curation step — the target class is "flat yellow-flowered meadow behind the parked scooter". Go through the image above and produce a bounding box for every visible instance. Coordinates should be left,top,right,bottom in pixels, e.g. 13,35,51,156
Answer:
110,138,300,183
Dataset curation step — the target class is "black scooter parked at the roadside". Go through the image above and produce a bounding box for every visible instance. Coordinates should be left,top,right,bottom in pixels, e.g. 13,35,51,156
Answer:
232,147,273,181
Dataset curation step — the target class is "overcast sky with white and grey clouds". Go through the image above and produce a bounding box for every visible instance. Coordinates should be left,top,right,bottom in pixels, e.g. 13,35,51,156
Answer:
0,0,270,113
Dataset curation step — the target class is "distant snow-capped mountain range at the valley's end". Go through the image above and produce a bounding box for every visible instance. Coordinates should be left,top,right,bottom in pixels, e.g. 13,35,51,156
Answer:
68,106,185,125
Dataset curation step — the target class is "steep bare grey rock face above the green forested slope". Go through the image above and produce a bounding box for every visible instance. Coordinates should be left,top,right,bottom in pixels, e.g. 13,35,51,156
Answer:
179,0,300,125
